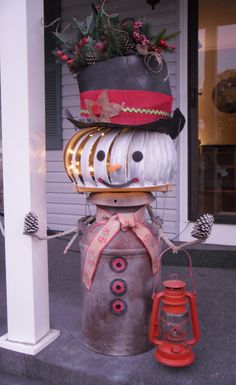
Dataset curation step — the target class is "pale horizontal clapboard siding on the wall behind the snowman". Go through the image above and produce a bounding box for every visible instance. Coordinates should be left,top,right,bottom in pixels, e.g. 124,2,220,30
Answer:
46,0,178,238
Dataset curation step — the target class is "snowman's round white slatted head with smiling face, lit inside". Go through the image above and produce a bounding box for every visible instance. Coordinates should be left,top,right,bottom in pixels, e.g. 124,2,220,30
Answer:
64,127,176,191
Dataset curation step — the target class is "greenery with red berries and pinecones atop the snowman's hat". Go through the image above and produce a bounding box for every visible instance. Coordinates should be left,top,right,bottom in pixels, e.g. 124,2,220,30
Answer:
53,0,178,73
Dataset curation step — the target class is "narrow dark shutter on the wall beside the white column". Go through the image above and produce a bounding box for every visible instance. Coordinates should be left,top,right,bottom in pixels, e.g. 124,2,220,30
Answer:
44,0,62,150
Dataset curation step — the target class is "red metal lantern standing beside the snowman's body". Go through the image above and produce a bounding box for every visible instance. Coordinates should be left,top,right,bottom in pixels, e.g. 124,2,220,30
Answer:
149,251,200,367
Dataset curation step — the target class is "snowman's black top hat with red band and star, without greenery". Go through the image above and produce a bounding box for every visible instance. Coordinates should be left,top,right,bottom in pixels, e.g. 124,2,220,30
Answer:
67,54,185,139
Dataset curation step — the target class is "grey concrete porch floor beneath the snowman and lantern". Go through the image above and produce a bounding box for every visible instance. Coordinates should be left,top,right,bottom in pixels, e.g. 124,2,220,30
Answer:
0,240,236,385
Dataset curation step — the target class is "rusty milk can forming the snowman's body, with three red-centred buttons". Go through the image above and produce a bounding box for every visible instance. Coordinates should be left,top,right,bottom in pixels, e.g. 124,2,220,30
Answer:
80,192,159,356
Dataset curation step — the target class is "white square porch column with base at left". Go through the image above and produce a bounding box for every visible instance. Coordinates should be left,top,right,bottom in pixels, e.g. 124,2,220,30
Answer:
0,0,59,355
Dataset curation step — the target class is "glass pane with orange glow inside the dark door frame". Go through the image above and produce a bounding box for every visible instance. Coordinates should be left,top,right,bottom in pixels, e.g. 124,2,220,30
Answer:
198,0,236,217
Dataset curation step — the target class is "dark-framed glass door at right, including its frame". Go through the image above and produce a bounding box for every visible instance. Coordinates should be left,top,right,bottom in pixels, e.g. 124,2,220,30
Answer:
188,0,236,223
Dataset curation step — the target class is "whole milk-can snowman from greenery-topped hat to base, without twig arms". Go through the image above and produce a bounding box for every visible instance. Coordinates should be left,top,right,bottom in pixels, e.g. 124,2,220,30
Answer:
56,2,185,355
